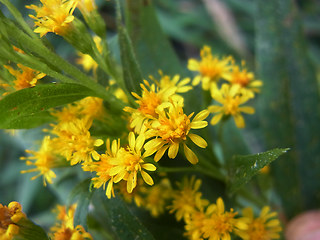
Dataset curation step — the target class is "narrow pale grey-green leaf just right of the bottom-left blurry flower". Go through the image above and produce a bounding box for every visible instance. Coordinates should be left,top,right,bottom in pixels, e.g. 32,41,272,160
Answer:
67,178,94,229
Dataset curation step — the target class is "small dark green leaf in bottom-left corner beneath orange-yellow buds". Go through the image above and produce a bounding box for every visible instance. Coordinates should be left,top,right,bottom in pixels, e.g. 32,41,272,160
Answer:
13,218,49,240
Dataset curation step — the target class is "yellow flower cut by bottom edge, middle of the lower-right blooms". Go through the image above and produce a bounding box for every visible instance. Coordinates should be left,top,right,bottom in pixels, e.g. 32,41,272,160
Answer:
202,198,248,240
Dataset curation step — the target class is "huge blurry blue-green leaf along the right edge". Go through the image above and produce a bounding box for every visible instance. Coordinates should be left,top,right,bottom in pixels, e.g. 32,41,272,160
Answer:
255,0,320,218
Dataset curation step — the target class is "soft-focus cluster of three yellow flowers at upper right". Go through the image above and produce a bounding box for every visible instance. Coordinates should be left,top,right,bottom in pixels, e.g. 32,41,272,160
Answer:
188,46,262,128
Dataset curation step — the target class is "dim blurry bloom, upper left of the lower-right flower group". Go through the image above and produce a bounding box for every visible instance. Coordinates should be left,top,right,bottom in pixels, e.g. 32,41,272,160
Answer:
169,176,209,221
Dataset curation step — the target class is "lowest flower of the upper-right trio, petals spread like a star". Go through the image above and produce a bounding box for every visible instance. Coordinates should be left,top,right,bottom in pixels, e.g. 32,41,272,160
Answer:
208,84,254,128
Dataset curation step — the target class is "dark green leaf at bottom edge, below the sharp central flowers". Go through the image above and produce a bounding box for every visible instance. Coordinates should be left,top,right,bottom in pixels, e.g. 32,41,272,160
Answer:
97,191,154,240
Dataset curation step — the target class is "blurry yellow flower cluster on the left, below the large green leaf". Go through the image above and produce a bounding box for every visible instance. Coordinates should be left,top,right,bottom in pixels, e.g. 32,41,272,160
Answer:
21,97,106,185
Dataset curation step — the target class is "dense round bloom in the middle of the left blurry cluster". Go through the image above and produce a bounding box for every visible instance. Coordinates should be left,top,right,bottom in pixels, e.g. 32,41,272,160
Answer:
51,118,103,165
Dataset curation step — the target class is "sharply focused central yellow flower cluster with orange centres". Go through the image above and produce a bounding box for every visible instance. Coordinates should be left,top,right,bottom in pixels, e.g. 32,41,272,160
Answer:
124,75,209,164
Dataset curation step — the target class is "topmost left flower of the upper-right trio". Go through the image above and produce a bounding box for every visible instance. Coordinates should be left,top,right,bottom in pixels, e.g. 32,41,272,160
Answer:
188,46,233,90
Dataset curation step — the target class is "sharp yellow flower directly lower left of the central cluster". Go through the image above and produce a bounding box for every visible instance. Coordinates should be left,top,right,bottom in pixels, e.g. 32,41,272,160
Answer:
109,132,156,193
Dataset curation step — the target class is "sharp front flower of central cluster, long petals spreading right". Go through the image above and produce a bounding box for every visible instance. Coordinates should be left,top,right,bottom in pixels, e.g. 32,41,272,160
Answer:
144,101,209,164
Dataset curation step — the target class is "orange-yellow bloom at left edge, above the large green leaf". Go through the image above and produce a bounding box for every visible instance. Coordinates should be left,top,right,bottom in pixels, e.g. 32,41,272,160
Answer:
4,64,46,94
